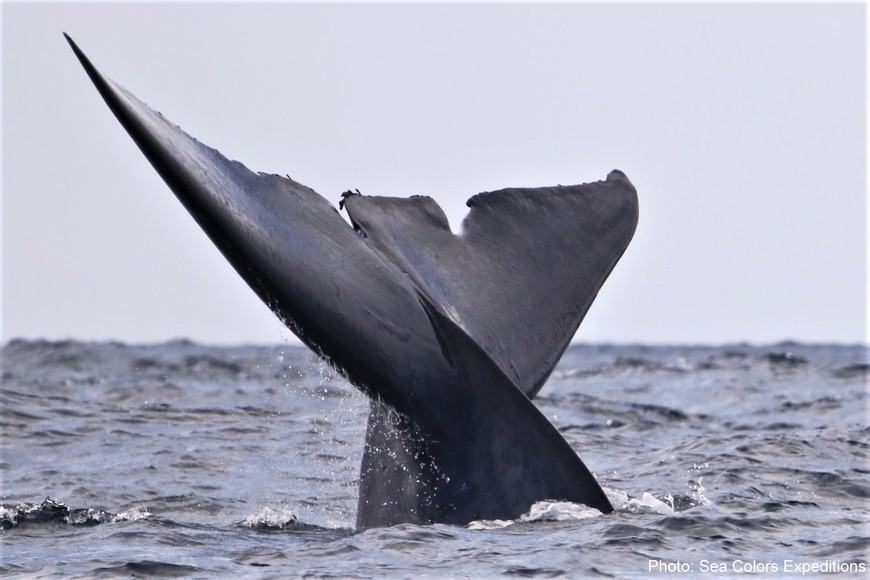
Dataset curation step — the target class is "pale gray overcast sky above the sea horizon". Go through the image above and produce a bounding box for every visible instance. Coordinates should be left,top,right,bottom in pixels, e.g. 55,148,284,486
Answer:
2,2,867,343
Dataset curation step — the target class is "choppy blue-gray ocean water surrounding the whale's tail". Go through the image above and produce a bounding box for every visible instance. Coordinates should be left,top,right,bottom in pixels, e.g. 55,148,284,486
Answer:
0,340,870,578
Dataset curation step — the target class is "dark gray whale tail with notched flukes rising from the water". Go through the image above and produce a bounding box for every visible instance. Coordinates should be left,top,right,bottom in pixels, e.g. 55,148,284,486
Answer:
65,35,638,528
